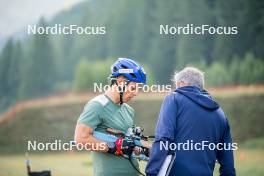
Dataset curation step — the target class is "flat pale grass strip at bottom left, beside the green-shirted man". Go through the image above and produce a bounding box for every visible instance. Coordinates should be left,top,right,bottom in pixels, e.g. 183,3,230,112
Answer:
0,153,92,176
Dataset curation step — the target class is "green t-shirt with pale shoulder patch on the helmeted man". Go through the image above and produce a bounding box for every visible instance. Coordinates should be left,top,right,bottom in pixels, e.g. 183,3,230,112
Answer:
78,94,138,176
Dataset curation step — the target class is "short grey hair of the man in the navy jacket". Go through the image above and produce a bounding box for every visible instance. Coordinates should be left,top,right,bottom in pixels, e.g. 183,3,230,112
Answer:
173,67,204,89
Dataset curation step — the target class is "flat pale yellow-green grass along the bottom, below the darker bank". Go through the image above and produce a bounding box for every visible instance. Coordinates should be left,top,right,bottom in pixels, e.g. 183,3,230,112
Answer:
0,149,264,176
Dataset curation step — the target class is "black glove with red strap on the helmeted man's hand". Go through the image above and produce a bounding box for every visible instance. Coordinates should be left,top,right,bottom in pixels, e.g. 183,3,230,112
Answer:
107,138,135,156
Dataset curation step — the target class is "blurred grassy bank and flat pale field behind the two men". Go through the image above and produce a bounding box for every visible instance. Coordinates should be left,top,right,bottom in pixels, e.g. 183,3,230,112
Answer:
0,86,264,176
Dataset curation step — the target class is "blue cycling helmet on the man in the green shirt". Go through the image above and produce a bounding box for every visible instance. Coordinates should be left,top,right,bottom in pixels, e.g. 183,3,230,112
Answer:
111,58,146,84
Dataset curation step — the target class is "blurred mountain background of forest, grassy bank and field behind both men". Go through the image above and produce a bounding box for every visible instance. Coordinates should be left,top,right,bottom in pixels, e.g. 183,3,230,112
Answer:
0,0,264,176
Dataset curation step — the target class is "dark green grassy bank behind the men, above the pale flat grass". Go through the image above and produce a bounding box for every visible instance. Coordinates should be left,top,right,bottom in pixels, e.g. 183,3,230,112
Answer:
0,94,264,154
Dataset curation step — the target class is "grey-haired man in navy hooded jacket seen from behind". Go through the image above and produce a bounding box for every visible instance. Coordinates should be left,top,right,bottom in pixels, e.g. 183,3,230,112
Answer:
146,67,236,176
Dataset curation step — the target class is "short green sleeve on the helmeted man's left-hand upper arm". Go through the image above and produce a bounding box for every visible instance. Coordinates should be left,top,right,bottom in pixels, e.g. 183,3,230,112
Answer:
78,102,102,129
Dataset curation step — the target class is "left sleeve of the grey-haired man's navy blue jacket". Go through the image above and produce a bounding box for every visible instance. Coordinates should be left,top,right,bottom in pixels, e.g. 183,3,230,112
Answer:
146,94,177,176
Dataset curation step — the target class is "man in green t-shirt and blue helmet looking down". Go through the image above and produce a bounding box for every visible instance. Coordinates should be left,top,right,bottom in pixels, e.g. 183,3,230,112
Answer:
75,58,146,176
